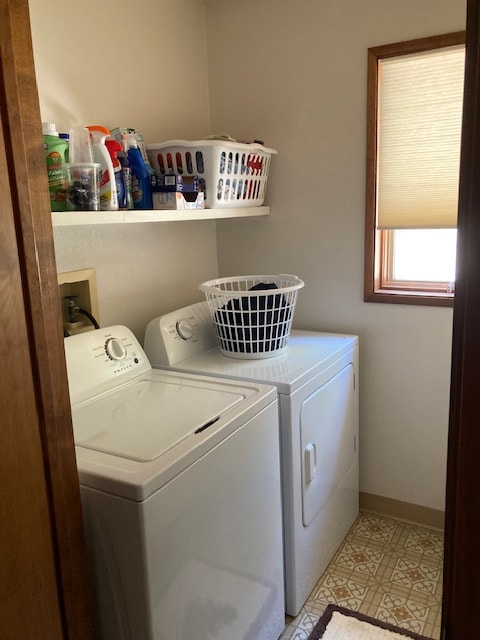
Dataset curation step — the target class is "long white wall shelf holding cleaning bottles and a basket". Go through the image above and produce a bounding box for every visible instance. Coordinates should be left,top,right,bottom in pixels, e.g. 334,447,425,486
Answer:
52,206,270,227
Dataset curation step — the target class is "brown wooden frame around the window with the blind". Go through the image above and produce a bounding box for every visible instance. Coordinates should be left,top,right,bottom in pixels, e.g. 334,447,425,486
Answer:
364,31,465,307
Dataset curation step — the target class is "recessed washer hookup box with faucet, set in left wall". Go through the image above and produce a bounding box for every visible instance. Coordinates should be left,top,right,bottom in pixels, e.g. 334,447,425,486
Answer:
57,269,100,335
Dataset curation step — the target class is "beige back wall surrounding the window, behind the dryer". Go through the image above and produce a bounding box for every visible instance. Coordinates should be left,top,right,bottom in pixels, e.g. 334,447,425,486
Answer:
203,0,465,509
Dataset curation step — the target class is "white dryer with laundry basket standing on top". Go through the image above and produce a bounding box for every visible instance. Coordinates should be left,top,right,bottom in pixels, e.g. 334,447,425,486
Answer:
144,302,358,616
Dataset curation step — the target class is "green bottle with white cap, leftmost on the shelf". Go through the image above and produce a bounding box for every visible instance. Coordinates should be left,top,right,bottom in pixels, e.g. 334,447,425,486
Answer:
42,122,68,211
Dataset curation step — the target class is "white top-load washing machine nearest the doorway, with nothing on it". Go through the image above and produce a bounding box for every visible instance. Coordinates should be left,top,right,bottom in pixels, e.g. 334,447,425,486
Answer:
65,326,285,640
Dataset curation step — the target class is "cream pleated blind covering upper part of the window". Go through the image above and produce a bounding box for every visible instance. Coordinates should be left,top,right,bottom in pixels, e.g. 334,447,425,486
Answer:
377,45,465,229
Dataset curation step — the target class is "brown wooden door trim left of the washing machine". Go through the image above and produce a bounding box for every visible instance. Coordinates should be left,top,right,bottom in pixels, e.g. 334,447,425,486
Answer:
0,0,93,640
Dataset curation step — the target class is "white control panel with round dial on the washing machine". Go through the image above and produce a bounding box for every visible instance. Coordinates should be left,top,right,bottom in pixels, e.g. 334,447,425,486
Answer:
64,325,151,402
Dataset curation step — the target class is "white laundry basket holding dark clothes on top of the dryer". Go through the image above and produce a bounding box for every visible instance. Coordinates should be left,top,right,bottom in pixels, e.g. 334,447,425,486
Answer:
199,274,304,360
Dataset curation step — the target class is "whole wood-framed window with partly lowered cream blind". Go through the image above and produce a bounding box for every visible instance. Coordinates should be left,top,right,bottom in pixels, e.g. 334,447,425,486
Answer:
365,32,465,306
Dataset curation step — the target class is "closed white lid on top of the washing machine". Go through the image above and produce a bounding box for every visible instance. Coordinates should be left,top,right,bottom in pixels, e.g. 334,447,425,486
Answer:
73,376,246,462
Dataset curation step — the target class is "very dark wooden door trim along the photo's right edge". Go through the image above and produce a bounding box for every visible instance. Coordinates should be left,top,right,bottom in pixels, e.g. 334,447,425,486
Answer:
442,0,480,640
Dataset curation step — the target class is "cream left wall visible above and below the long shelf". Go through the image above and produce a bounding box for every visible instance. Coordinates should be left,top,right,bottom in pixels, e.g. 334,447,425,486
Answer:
29,0,217,339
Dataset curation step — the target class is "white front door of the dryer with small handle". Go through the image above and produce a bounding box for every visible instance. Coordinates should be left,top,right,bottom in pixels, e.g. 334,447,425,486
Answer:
300,364,356,526
